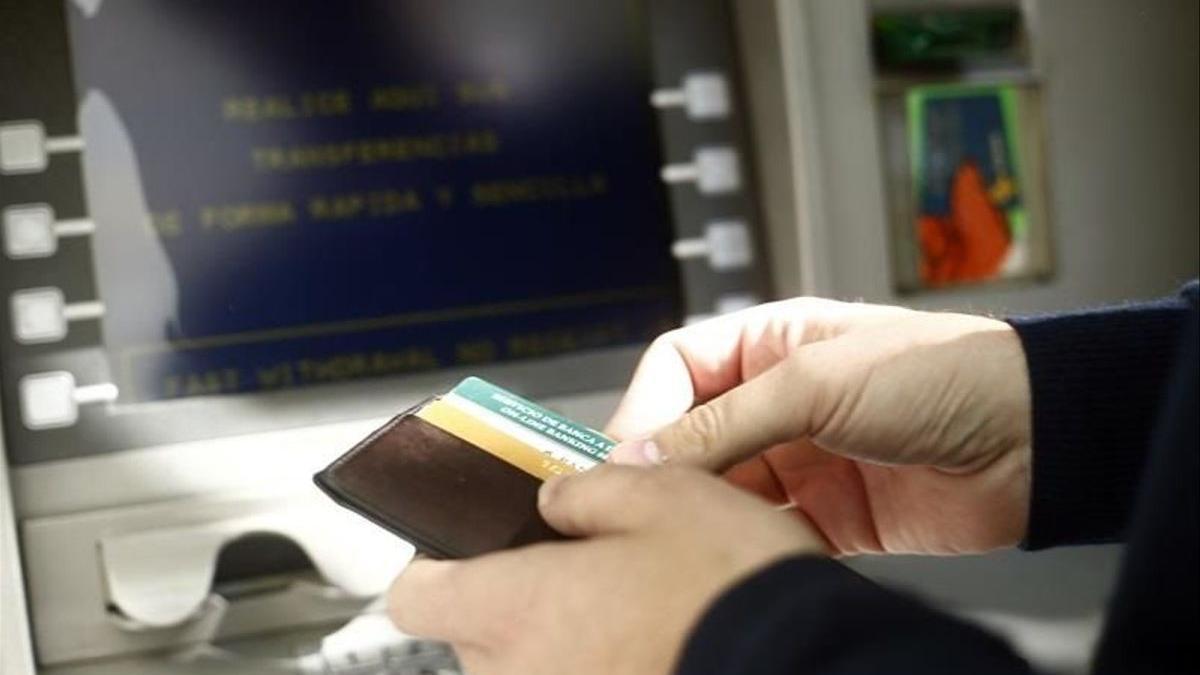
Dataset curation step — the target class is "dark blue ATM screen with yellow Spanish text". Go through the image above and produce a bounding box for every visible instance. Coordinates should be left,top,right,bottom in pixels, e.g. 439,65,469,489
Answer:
67,0,682,401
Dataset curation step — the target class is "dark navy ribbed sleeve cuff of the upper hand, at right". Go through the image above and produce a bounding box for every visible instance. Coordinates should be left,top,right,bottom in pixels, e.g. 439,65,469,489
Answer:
1009,281,1198,549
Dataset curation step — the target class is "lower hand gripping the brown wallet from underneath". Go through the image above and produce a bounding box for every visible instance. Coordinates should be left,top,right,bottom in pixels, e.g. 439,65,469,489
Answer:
389,466,822,675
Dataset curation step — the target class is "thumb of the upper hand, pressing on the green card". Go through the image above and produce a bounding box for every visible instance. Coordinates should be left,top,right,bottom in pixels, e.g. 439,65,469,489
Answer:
611,350,828,471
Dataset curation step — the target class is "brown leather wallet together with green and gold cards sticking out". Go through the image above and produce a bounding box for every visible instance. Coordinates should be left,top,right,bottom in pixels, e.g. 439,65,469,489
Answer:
314,377,616,557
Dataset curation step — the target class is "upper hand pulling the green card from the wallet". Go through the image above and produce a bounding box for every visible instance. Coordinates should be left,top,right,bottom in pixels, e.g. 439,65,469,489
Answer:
608,298,1031,554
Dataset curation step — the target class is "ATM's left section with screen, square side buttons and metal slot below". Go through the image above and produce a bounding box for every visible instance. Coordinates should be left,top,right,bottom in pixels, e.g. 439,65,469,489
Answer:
0,0,769,674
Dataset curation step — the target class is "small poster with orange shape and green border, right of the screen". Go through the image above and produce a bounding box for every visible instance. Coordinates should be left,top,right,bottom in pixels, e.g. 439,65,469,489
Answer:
883,84,1052,292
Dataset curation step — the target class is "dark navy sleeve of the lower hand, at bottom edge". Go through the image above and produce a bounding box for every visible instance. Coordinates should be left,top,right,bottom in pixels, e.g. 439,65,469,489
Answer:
678,557,1030,675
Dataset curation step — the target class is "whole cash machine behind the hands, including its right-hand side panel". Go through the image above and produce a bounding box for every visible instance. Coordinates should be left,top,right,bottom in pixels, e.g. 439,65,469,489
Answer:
0,0,1200,675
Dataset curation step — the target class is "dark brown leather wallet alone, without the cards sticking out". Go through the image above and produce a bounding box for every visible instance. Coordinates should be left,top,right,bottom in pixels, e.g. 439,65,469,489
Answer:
313,401,563,558
